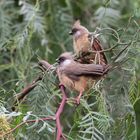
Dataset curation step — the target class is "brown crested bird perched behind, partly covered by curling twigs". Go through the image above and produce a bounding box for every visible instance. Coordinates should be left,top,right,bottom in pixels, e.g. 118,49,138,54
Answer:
69,20,107,65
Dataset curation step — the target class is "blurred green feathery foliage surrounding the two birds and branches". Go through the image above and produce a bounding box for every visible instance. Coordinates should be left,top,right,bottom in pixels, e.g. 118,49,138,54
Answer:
0,0,140,140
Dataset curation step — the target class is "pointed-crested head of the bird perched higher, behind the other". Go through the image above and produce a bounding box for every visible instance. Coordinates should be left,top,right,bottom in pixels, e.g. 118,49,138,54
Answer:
69,20,89,38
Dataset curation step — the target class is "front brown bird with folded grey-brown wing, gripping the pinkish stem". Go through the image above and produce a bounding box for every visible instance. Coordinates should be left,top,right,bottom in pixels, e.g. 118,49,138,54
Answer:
57,52,106,104
